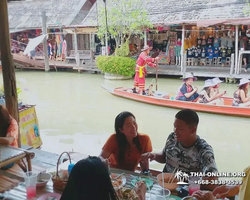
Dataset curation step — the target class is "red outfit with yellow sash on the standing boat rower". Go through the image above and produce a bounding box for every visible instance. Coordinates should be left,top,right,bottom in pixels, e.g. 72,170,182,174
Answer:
134,52,156,91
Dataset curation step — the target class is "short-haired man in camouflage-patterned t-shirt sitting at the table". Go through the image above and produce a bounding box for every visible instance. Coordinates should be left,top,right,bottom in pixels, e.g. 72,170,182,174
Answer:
141,109,218,189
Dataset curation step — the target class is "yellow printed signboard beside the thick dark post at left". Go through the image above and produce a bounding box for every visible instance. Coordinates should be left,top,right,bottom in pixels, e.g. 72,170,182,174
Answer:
19,106,42,148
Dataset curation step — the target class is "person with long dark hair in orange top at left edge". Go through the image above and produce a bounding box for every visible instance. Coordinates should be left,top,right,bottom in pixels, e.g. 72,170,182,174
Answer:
0,105,18,147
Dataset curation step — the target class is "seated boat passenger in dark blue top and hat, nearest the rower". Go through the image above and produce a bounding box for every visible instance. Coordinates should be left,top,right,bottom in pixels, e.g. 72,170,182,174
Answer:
175,72,199,102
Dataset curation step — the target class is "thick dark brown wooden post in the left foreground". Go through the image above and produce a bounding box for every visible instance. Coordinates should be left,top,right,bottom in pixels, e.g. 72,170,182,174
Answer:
0,0,21,147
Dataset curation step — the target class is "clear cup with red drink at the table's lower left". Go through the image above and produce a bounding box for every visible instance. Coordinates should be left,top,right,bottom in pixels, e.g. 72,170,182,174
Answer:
24,171,37,199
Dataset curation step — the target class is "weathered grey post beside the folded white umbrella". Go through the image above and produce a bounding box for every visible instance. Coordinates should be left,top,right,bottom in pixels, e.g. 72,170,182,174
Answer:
42,11,49,72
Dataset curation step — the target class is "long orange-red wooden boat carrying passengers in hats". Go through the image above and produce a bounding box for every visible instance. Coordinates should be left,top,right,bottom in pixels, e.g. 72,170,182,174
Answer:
102,86,250,117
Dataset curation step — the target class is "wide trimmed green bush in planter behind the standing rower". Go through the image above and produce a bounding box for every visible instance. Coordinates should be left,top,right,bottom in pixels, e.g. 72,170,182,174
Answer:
97,56,136,76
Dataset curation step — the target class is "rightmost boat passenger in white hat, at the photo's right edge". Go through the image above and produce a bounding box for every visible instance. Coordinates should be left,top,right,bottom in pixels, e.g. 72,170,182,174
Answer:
232,78,250,107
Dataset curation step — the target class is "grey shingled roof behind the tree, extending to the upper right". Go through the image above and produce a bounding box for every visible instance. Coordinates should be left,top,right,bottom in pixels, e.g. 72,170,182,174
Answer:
82,0,250,26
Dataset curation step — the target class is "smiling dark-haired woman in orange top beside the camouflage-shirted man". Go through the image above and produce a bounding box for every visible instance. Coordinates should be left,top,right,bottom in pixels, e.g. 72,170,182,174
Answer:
100,111,152,171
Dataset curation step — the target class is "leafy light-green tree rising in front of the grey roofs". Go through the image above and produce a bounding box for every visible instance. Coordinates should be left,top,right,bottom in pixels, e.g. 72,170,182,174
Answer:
97,0,153,55
